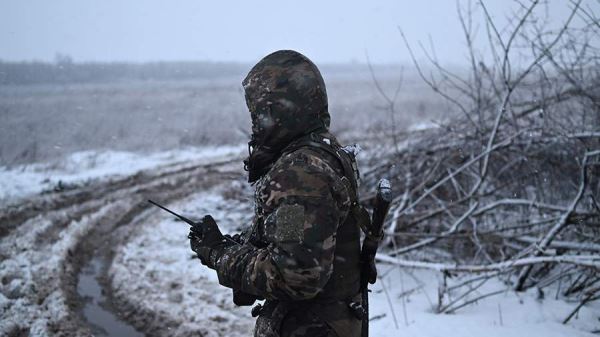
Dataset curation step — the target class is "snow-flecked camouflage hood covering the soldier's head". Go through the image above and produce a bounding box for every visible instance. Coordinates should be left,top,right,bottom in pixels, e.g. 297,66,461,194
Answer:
242,50,330,182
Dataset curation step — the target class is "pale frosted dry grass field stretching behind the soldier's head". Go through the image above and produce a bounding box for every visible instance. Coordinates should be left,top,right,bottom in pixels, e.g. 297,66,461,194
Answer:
0,66,444,166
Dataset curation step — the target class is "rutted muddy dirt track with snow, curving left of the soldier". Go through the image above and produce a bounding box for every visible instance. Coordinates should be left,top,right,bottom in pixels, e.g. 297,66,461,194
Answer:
0,157,248,336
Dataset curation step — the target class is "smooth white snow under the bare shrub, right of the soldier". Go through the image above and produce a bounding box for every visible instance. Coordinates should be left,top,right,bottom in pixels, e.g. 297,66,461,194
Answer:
369,263,600,337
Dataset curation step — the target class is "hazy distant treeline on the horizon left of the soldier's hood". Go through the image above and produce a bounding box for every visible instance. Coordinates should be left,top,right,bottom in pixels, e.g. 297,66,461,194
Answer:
0,58,248,85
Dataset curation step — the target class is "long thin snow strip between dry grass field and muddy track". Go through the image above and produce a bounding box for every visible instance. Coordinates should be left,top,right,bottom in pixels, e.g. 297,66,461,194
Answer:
0,145,245,206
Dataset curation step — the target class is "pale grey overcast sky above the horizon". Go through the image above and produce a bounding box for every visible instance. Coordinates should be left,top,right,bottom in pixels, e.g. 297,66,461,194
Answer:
0,0,600,63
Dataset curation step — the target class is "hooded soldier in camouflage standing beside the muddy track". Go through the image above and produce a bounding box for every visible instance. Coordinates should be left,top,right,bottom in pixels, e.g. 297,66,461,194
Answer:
189,50,364,337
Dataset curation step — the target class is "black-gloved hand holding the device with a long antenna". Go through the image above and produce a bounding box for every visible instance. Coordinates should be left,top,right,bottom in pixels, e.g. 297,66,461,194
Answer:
188,215,233,269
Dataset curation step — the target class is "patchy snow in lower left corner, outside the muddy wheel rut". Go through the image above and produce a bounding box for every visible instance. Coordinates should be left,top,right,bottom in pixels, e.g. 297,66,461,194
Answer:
0,201,114,336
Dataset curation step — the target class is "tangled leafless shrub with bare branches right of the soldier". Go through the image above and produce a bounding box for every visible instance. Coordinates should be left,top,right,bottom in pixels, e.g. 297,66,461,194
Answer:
364,0,600,323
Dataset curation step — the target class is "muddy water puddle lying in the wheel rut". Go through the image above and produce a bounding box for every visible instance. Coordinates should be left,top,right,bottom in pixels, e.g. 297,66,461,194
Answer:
77,258,144,337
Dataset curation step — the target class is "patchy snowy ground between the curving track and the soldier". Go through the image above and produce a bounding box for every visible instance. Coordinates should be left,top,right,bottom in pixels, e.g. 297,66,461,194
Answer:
109,181,253,337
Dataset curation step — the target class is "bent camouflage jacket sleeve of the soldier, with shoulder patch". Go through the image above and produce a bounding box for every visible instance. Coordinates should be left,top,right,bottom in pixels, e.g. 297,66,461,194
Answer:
216,151,350,300
